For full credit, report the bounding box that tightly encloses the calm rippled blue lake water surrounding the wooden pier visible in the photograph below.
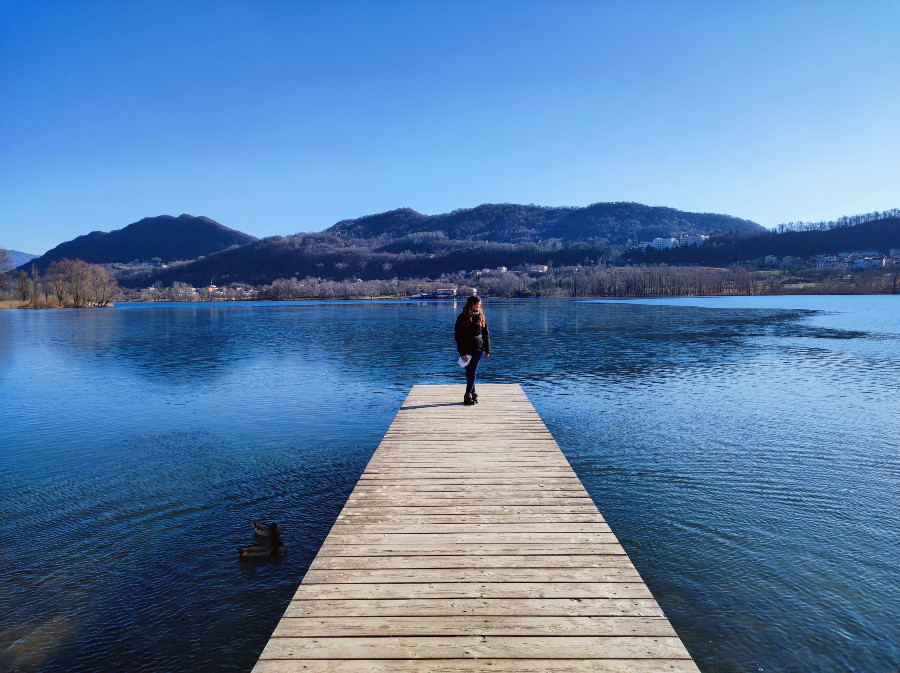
[0,296,900,673]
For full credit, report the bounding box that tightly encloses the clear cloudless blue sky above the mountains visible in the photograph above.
[0,0,900,253]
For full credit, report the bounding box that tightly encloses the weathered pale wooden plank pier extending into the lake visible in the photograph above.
[253,385,698,673]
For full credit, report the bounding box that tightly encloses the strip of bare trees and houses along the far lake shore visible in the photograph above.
[0,252,900,308]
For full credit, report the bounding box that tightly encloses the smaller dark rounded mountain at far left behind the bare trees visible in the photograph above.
[23,215,257,271]
